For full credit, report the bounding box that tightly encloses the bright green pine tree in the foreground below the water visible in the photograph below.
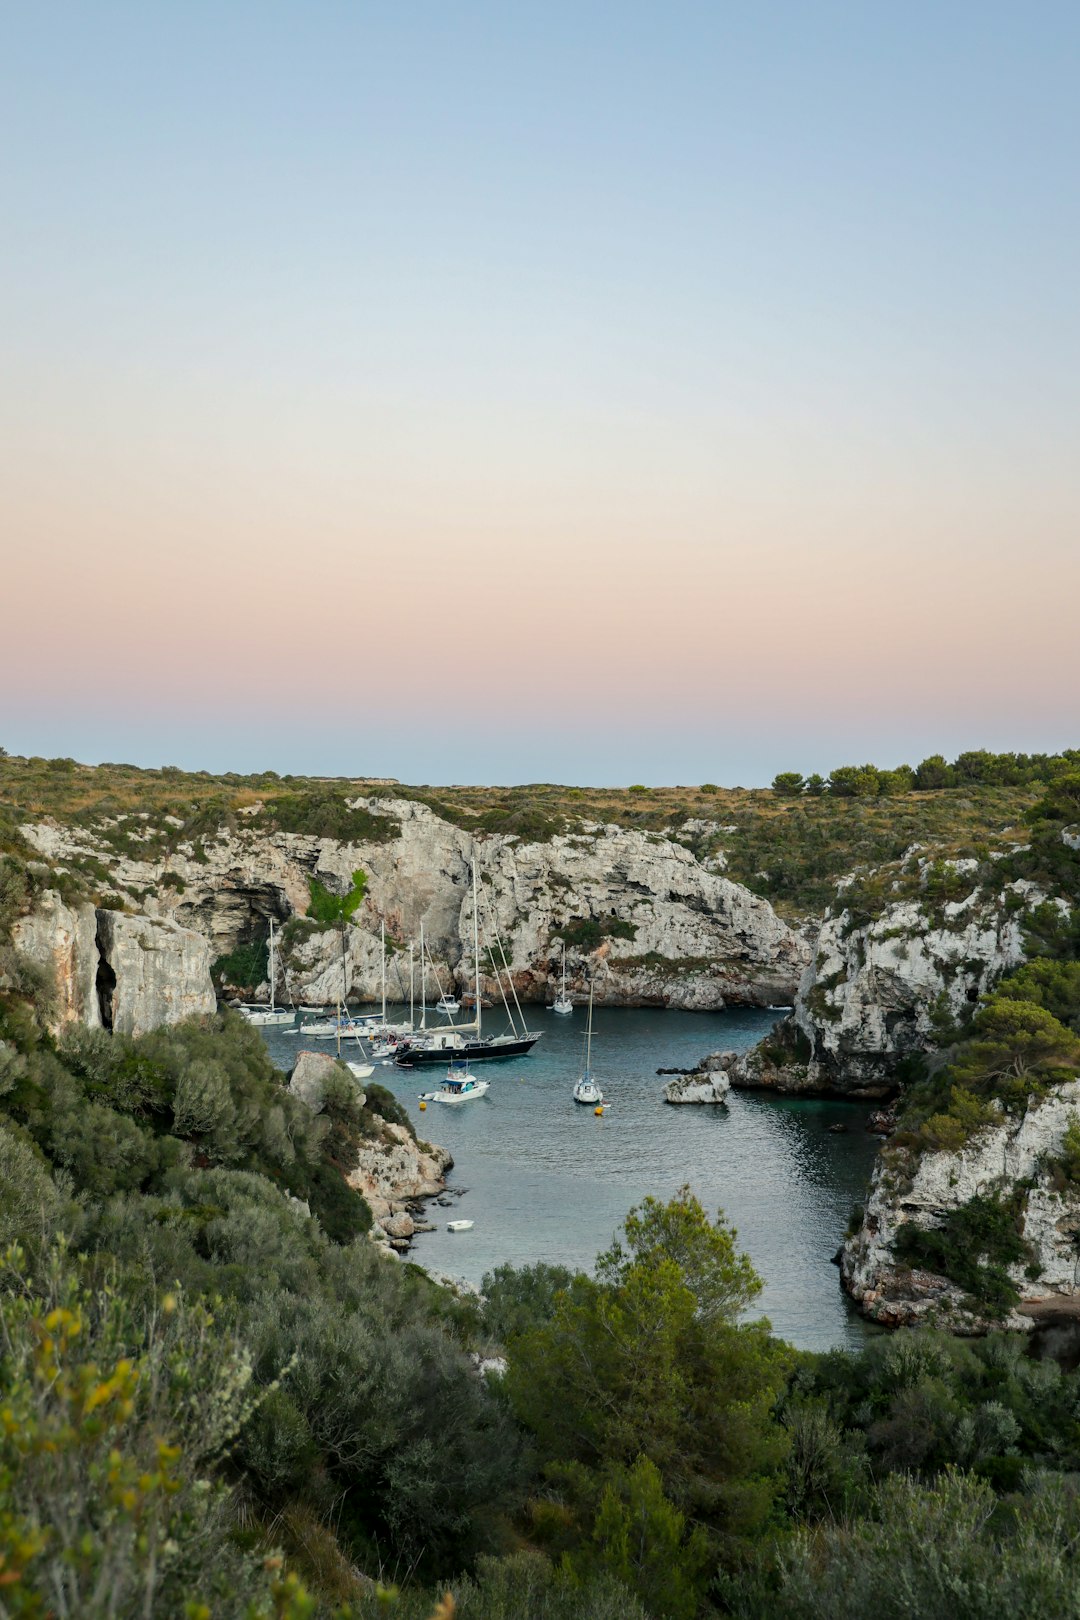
[507,1187,789,1555]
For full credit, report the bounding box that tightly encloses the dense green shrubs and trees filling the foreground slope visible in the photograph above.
[0,920,1080,1620]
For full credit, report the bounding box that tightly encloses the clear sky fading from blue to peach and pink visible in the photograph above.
[0,0,1080,786]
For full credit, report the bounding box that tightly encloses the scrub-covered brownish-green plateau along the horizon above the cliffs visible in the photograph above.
[0,753,1070,919]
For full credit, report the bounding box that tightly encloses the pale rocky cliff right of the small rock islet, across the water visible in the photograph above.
[730,862,1043,1097]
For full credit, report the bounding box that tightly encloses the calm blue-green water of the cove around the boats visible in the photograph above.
[264,1008,876,1349]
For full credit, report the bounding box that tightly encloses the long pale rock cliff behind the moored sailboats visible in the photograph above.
[24,800,808,1009]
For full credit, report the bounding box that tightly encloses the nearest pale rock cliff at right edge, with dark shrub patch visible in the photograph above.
[840,1079,1080,1332]
